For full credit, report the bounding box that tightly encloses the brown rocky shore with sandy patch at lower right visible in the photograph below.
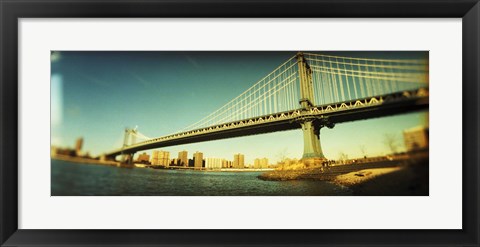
[258,158,428,196]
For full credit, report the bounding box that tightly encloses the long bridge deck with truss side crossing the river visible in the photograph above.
[104,88,429,157]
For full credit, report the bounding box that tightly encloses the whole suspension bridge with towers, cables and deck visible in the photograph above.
[103,52,429,162]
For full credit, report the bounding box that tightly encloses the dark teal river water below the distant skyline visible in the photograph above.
[51,160,350,196]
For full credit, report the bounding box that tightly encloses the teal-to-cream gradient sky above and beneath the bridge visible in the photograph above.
[51,51,428,164]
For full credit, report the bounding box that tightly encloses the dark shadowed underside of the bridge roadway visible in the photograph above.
[105,96,429,158]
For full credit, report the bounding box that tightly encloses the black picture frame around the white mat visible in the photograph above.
[0,0,480,246]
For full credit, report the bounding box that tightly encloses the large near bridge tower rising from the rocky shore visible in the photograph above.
[297,52,333,163]
